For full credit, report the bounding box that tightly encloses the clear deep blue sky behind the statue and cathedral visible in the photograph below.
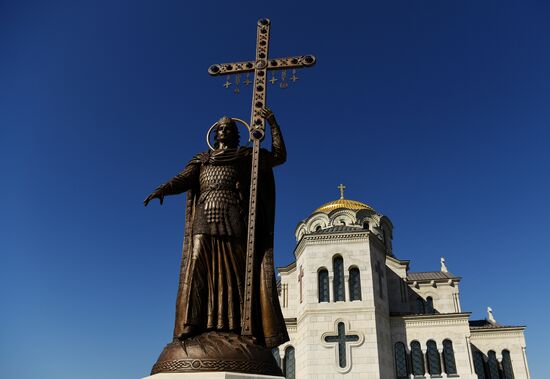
[0,0,550,379]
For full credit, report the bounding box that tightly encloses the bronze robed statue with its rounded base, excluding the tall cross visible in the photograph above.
[144,108,288,375]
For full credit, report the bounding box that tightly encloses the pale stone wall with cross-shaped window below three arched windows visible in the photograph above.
[291,235,391,379]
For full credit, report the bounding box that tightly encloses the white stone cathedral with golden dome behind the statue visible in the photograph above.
[273,189,530,379]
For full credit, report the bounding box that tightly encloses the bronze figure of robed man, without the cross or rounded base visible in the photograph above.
[144,108,288,348]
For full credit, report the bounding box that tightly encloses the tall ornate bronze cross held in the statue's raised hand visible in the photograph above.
[208,18,315,335]
